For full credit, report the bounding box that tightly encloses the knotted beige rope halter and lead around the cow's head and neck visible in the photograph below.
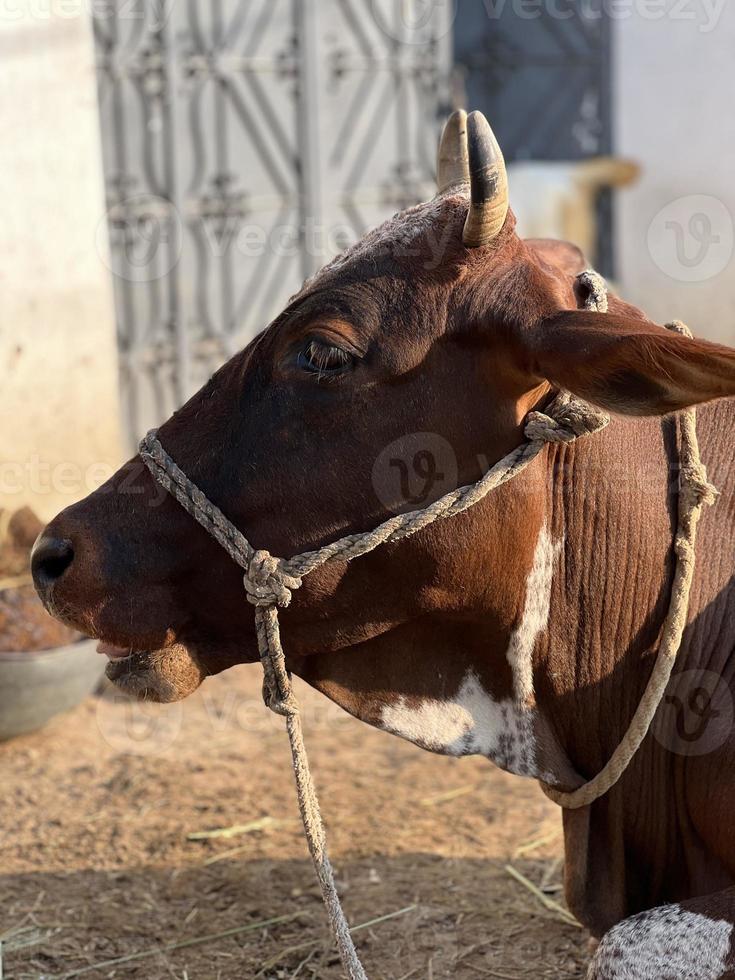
[140,270,714,980]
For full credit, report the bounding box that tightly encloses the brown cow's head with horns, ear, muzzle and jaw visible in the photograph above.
[33,112,735,756]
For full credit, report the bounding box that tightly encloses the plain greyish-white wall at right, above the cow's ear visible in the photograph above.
[614,0,735,344]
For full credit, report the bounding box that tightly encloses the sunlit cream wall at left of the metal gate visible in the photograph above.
[0,2,121,518]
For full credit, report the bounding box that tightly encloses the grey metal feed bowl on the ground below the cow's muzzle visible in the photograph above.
[0,640,106,740]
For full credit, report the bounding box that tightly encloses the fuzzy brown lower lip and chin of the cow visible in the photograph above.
[97,641,206,703]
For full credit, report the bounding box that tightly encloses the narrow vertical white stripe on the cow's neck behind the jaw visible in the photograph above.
[506,525,562,708]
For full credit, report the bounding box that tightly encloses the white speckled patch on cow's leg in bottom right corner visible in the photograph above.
[588,905,733,980]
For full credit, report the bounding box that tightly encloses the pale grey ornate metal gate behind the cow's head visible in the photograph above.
[93,0,453,442]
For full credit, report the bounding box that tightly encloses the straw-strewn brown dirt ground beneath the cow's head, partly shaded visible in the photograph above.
[0,667,586,980]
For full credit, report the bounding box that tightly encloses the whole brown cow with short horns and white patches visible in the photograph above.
[33,113,735,980]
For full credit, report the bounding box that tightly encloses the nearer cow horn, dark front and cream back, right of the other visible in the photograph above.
[462,112,508,248]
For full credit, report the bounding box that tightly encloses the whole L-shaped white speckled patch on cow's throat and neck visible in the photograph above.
[380,527,561,778]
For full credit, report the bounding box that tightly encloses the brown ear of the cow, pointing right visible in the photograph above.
[527,310,735,415]
